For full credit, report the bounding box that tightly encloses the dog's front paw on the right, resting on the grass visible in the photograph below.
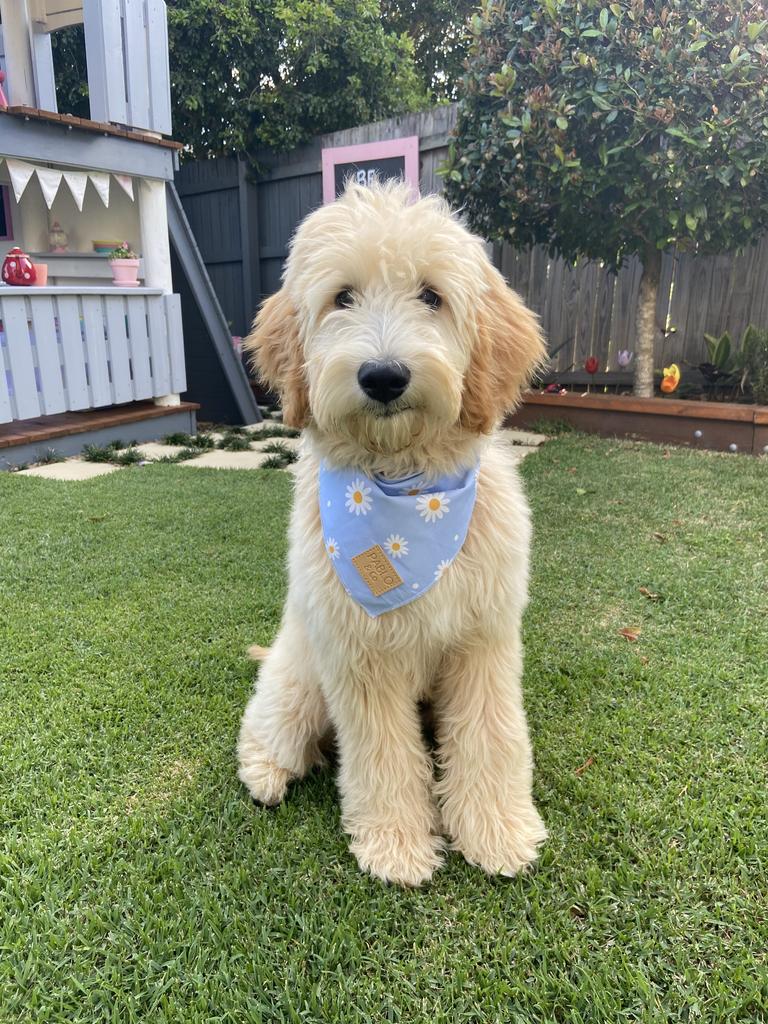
[447,805,547,876]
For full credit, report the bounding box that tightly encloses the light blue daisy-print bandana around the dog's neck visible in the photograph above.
[319,463,477,617]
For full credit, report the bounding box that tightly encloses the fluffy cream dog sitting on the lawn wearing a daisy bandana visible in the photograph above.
[238,182,547,886]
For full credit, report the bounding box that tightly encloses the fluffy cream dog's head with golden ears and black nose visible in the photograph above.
[247,183,545,464]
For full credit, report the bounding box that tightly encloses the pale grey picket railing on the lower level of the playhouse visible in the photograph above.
[0,287,186,423]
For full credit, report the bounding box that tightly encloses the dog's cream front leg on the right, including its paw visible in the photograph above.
[435,622,547,874]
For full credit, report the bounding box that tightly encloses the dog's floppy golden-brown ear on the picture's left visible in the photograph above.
[244,289,309,428]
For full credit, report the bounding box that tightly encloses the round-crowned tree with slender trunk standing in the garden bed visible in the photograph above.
[446,0,768,395]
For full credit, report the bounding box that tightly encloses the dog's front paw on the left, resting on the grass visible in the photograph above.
[349,828,443,886]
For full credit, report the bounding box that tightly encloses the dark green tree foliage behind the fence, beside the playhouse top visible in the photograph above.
[53,0,429,158]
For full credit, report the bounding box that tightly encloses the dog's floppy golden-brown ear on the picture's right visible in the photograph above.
[460,263,546,434]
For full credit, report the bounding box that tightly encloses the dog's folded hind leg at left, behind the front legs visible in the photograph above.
[238,615,329,805]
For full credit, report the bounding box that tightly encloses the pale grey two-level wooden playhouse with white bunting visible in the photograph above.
[0,0,197,468]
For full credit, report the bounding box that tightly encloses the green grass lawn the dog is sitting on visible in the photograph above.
[0,436,768,1024]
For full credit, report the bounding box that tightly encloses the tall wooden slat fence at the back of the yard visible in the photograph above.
[176,99,768,373]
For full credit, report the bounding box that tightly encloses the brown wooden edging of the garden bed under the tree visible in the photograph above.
[506,391,768,455]
